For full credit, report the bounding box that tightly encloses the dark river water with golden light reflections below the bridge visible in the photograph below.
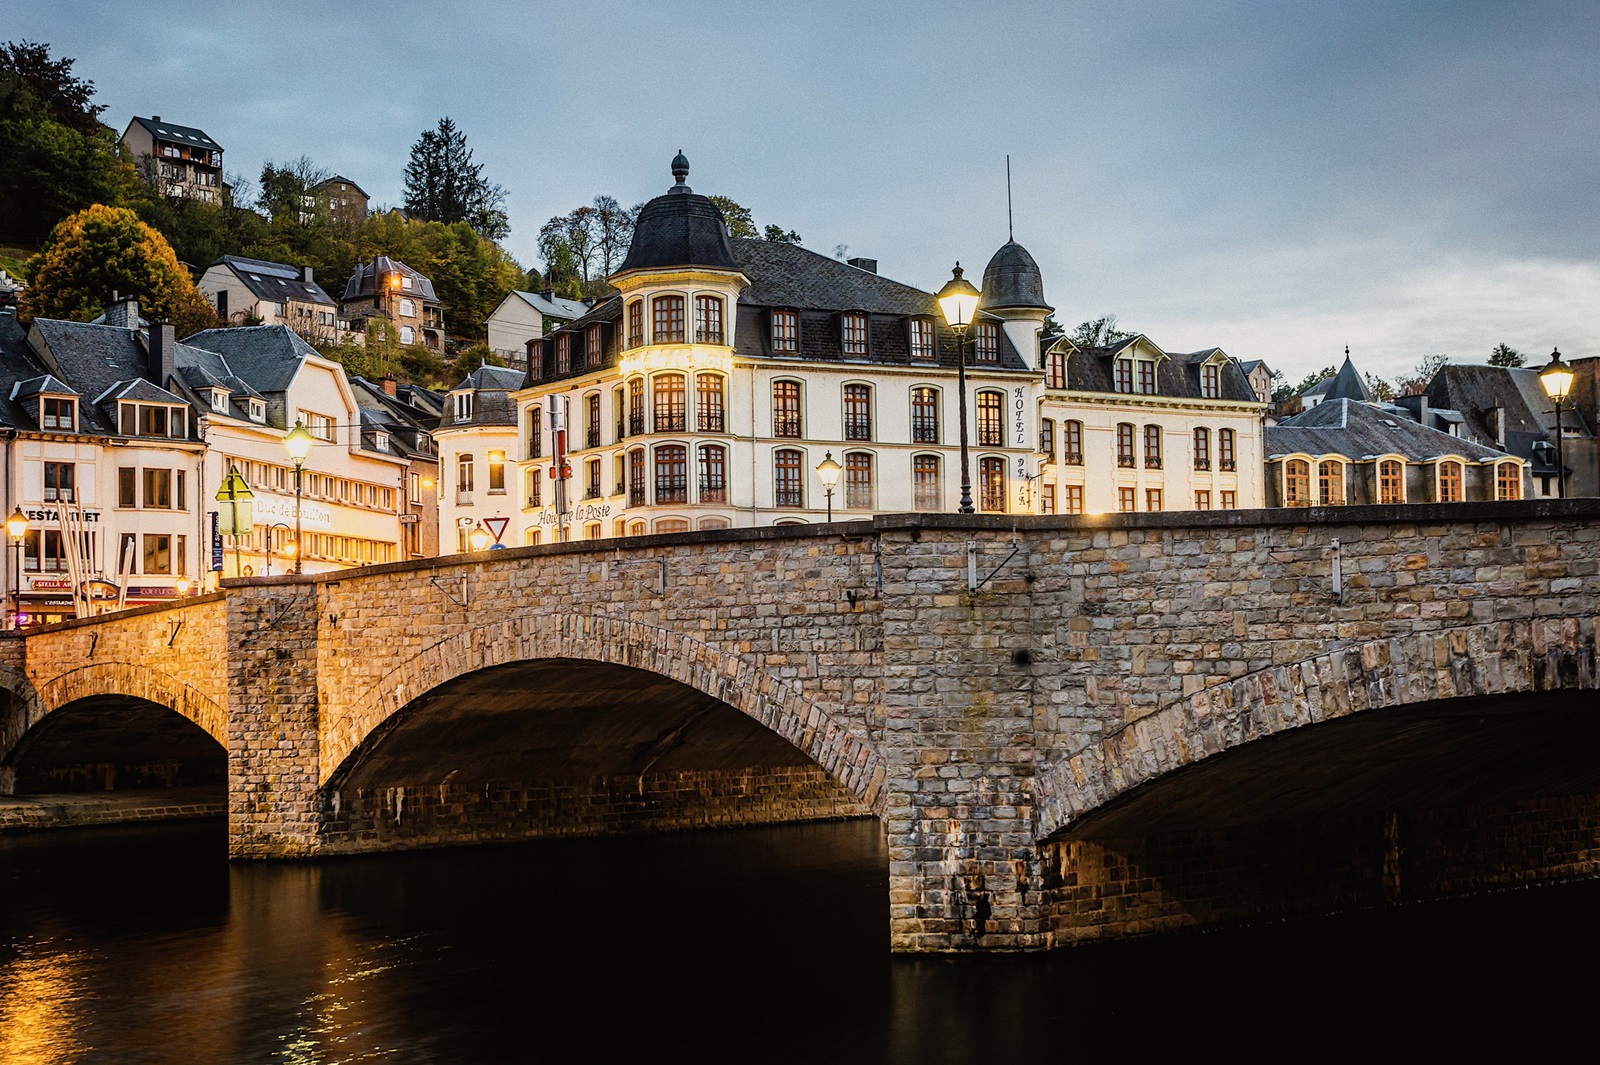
[0,822,1600,1065]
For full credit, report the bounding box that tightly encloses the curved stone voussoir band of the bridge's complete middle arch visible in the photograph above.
[318,612,886,817]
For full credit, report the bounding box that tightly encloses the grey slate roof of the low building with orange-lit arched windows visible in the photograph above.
[1264,400,1510,462]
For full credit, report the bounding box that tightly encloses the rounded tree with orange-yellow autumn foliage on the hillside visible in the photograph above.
[19,205,216,336]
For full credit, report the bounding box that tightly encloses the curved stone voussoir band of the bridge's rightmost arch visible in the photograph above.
[1037,617,1600,843]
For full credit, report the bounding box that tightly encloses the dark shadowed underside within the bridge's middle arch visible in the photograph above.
[322,657,872,852]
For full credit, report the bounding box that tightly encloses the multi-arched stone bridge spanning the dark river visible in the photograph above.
[0,501,1600,950]
